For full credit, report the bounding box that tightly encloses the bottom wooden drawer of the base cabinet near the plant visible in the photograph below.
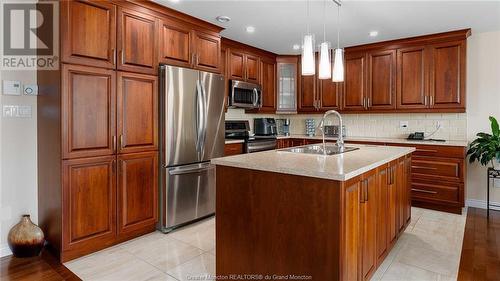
[411,181,460,203]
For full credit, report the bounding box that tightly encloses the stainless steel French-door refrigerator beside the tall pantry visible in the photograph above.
[159,65,224,232]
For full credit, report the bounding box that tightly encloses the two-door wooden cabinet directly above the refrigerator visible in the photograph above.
[160,18,221,73]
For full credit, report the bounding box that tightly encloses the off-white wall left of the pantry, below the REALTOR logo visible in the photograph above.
[0,71,38,256]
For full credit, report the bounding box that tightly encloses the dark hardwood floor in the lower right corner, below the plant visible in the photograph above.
[458,208,500,281]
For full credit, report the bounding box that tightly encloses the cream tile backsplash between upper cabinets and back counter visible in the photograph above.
[226,109,467,140]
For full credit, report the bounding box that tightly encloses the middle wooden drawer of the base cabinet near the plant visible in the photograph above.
[411,157,464,182]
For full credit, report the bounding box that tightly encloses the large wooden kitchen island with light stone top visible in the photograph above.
[212,145,415,281]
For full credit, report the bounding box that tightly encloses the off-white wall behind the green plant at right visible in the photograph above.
[467,31,500,207]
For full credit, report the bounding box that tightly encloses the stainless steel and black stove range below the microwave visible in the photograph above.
[226,120,277,153]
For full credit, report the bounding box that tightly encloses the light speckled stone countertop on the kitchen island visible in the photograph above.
[212,144,415,181]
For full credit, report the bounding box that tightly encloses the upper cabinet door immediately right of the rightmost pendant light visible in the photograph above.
[342,53,366,111]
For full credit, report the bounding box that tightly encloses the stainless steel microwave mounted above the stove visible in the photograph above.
[229,80,262,108]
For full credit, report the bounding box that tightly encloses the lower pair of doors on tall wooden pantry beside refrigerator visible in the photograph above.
[61,151,158,261]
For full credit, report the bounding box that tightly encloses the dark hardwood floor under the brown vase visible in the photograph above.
[0,250,81,281]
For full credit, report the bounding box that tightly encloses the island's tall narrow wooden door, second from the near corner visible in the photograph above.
[361,170,378,280]
